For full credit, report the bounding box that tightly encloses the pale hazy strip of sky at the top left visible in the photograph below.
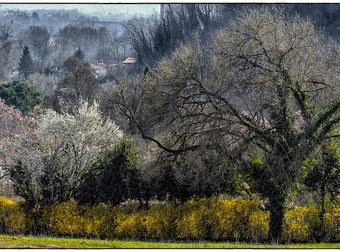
[0,3,160,15]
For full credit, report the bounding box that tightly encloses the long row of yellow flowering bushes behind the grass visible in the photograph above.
[0,198,340,242]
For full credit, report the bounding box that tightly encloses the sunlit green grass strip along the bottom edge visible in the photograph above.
[0,235,340,249]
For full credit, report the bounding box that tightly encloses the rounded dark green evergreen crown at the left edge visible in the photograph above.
[0,81,43,114]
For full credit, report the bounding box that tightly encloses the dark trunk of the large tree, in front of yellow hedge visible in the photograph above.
[269,196,286,243]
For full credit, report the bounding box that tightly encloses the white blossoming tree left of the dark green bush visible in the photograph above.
[9,99,123,204]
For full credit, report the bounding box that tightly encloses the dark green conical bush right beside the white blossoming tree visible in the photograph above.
[75,137,142,205]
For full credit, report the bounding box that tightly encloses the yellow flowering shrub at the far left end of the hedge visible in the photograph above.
[0,197,25,233]
